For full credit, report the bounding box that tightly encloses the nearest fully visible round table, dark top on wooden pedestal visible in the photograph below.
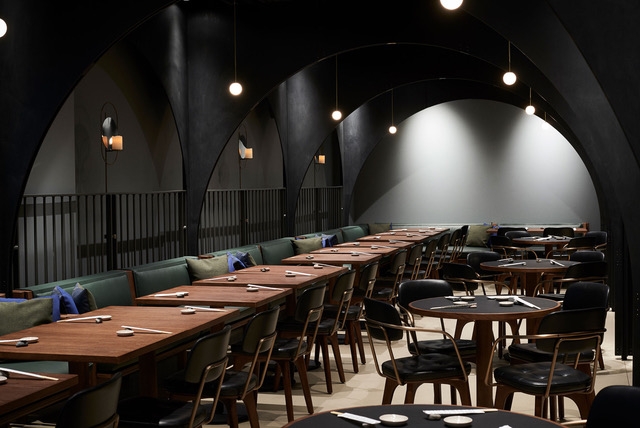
[409,296,560,407]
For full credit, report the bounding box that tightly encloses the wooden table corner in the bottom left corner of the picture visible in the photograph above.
[0,372,78,427]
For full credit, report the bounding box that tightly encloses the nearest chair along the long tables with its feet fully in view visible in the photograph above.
[271,284,327,421]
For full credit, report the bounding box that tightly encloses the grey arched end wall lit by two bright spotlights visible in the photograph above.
[352,100,600,230]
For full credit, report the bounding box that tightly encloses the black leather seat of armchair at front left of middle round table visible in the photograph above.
[382,354,471,382]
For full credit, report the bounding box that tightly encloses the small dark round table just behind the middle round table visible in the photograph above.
[480,259,580,296]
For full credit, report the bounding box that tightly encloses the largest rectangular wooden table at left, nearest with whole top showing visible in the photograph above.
[0,306,238,396]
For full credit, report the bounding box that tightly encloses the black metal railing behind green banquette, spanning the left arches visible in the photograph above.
[13,187,342,287]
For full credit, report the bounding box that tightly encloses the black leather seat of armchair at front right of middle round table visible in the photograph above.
[493,362,591,395]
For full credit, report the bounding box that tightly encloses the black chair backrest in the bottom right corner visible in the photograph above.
[585,385,640,428]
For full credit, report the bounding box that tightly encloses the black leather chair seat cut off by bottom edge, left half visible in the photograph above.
[118,397,211,428]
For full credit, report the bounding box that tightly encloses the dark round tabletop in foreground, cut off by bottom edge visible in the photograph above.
[284,404,562,428]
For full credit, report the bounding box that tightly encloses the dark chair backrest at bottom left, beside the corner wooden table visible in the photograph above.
[56,372,122,428]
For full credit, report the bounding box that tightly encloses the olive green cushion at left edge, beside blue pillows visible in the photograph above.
[0,299,53,335]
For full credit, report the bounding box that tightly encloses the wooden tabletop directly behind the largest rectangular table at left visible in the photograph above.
[136,285,292,309]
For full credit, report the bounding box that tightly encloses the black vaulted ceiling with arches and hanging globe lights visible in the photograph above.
[0,0,640,383]
